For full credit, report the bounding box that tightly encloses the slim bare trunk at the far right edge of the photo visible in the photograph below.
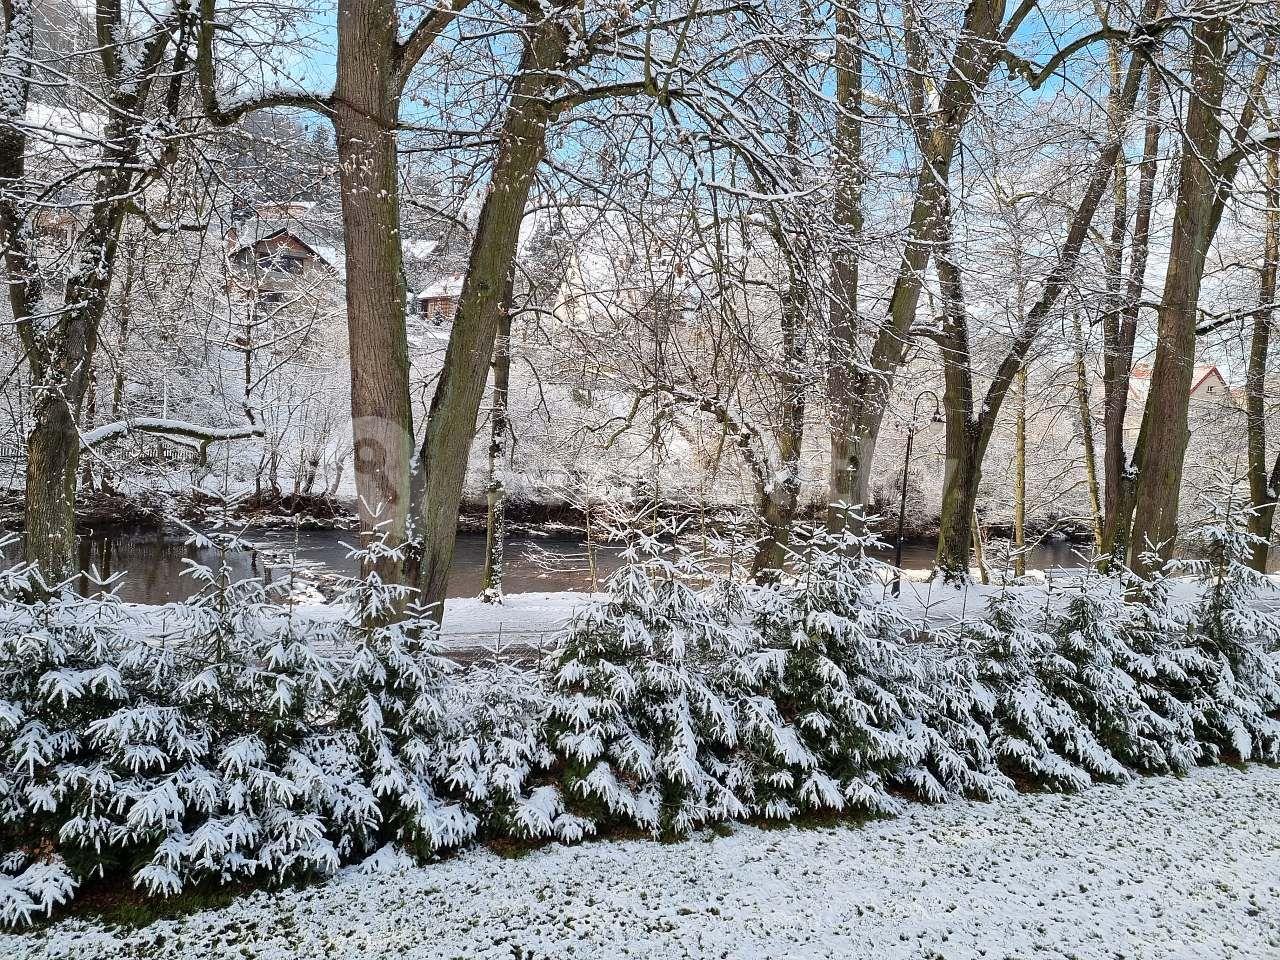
[1244,140,1280,573]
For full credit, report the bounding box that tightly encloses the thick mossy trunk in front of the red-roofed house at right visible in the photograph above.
[1129,18,1229,568]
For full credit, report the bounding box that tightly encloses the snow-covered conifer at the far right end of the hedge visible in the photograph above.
[1178,497,1280,762]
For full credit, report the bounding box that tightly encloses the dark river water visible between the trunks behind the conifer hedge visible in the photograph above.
[0,530,1100,603]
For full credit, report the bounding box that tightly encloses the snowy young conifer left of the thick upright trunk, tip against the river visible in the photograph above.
[128,534,351,895]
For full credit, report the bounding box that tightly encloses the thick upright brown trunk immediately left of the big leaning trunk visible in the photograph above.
[333,0,413,581]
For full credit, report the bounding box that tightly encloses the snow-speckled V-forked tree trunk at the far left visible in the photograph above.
[0,0,195,585]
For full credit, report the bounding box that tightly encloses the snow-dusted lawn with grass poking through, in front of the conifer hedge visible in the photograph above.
[10,767,1280,960]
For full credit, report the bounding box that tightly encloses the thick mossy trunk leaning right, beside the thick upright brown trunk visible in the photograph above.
[412,18,570,617]
